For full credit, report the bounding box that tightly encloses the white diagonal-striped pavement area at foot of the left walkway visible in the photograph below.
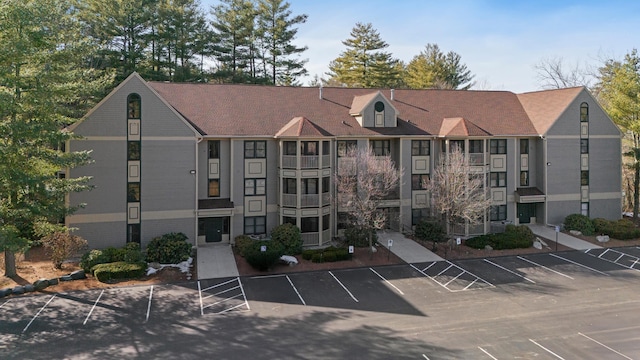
[197,277,249,315]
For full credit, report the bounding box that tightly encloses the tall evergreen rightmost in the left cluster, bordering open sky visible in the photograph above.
[258,0,308,85]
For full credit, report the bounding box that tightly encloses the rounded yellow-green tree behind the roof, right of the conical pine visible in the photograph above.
[404,44,474,90]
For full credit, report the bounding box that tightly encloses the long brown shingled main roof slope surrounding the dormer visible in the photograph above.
[149,82,568,137]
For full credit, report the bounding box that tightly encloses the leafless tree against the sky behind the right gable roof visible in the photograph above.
[533,57,593,89]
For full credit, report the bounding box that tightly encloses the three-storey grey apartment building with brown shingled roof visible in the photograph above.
[66,74,621,248]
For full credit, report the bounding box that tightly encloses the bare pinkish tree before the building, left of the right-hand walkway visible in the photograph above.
[335,147,402,248]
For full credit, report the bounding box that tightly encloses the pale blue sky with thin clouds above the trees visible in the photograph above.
[201,0,640,93]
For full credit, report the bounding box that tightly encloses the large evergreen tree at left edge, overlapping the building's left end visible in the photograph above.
[0,0,111,276]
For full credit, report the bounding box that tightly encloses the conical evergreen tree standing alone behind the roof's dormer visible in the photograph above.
[327,23,400,88]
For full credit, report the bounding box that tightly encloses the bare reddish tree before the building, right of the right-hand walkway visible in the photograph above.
[427,148,491,234]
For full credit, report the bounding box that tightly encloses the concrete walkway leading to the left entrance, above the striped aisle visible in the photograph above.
[197,244,239,280]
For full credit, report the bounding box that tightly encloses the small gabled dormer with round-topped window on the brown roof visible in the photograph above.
[349,90,398,128]
